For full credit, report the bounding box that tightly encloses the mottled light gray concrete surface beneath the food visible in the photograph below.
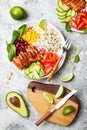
[0,0,87,130]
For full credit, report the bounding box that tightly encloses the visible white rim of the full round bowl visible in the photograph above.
[12,21,66,78]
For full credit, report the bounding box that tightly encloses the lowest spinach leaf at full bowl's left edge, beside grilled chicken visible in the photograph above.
[7,43,16,61]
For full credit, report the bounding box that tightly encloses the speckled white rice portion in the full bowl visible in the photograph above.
[33,26,61,53]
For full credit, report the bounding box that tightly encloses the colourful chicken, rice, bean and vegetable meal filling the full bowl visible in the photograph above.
[7,19,63,79]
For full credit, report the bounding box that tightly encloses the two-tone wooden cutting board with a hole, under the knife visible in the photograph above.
[27,81,79,126]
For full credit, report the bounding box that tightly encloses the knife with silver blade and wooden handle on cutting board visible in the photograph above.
[35,90,77,126]
